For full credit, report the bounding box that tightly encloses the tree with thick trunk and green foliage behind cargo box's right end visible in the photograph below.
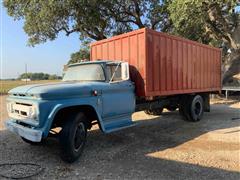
[168,0,240,83]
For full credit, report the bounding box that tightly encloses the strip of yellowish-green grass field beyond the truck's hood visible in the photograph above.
[0,80,59,94]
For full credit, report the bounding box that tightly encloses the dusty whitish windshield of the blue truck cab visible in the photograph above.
[63,64,105,81]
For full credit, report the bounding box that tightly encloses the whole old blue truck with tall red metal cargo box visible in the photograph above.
[6,28,221,162]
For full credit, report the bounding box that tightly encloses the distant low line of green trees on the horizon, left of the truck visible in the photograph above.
[18,73,61,80]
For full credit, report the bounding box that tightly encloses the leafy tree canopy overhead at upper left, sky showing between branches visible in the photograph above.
[4,0,171,46]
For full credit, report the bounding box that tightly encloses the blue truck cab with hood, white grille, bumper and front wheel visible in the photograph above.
[6,61,136,162]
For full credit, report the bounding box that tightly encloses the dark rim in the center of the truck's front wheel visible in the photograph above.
[74,122,86,151]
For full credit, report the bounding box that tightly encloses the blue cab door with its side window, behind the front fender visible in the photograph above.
[102,64,135,132]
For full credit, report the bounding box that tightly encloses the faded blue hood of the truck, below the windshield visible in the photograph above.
[9,82,106,99]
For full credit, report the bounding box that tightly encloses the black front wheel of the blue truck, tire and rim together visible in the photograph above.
[60,112,87,163]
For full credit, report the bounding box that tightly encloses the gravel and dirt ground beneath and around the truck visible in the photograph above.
[0,96,240,180]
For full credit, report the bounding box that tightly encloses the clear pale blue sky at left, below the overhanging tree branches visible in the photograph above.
[0,3,80,79]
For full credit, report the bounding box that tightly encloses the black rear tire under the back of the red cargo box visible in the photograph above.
[179,95,204,122]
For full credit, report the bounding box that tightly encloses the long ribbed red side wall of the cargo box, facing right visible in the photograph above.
[145,29,221,96]
